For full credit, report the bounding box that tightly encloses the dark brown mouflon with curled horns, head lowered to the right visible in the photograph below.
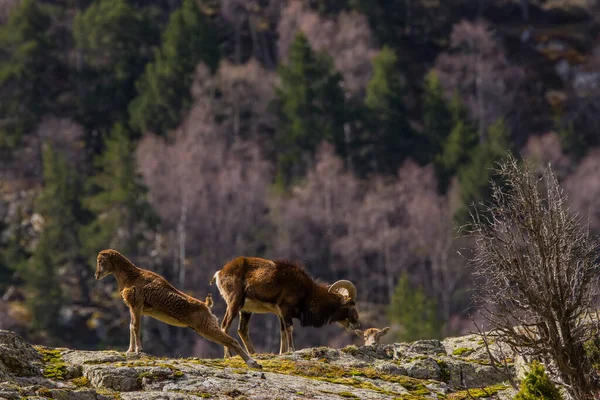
[210,257,360,356]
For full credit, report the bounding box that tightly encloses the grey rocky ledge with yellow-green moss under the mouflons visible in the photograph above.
[0,330,514,400]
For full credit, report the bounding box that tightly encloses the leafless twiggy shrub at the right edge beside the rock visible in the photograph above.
[470,156,600,399]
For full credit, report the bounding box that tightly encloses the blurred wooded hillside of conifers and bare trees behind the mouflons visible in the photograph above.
[0,0,600,356]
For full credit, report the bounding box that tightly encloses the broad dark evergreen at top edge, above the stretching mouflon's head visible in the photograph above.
[73,0,160,134]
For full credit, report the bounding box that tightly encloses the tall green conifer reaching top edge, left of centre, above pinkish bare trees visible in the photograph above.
[129,0,220,134]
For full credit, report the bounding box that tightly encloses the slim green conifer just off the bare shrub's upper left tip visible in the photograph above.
[456,118,512,221]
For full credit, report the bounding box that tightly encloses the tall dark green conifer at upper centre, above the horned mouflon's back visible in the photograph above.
[275,33,345,186]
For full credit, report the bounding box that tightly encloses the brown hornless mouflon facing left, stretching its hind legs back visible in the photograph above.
[96,250,261,368]
